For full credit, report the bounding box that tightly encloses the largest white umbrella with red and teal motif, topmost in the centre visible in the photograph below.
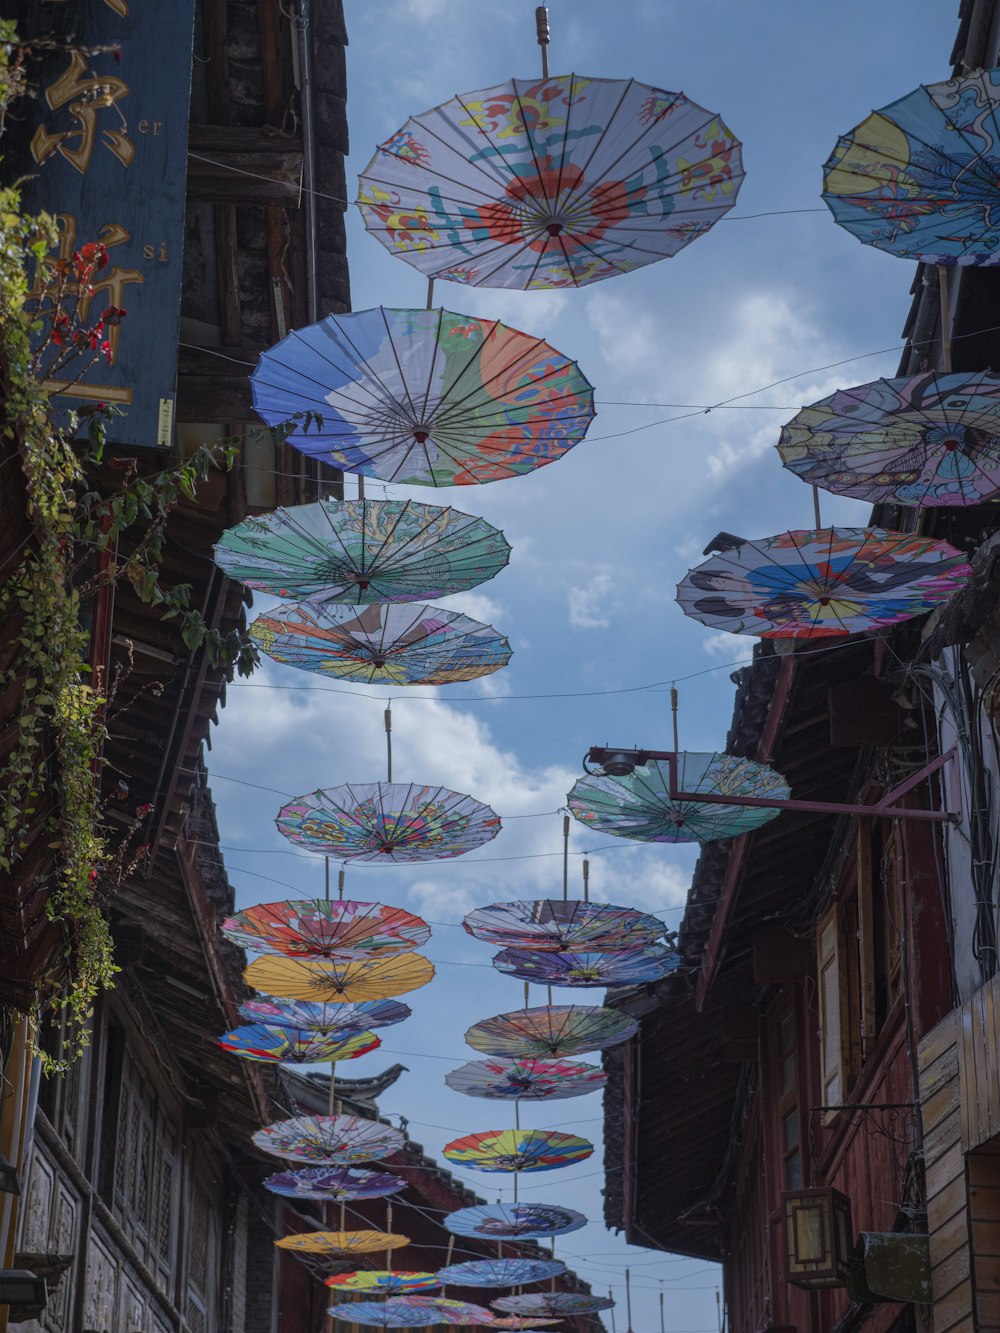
[357,75,743,288]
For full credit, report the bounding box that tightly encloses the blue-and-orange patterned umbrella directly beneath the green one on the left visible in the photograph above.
[249,603,511,685]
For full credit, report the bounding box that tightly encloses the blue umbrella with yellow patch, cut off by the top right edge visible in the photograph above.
[823,69,1000,264]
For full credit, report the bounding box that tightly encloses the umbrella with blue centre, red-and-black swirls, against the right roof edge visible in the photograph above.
[677,528,972,639]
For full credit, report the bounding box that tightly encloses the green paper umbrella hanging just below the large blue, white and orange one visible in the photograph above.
[215,500,511,605]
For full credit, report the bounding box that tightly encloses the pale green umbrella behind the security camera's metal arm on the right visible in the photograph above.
[567,750,789,842]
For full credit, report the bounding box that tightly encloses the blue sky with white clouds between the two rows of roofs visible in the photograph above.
[211,0,957,1333]
